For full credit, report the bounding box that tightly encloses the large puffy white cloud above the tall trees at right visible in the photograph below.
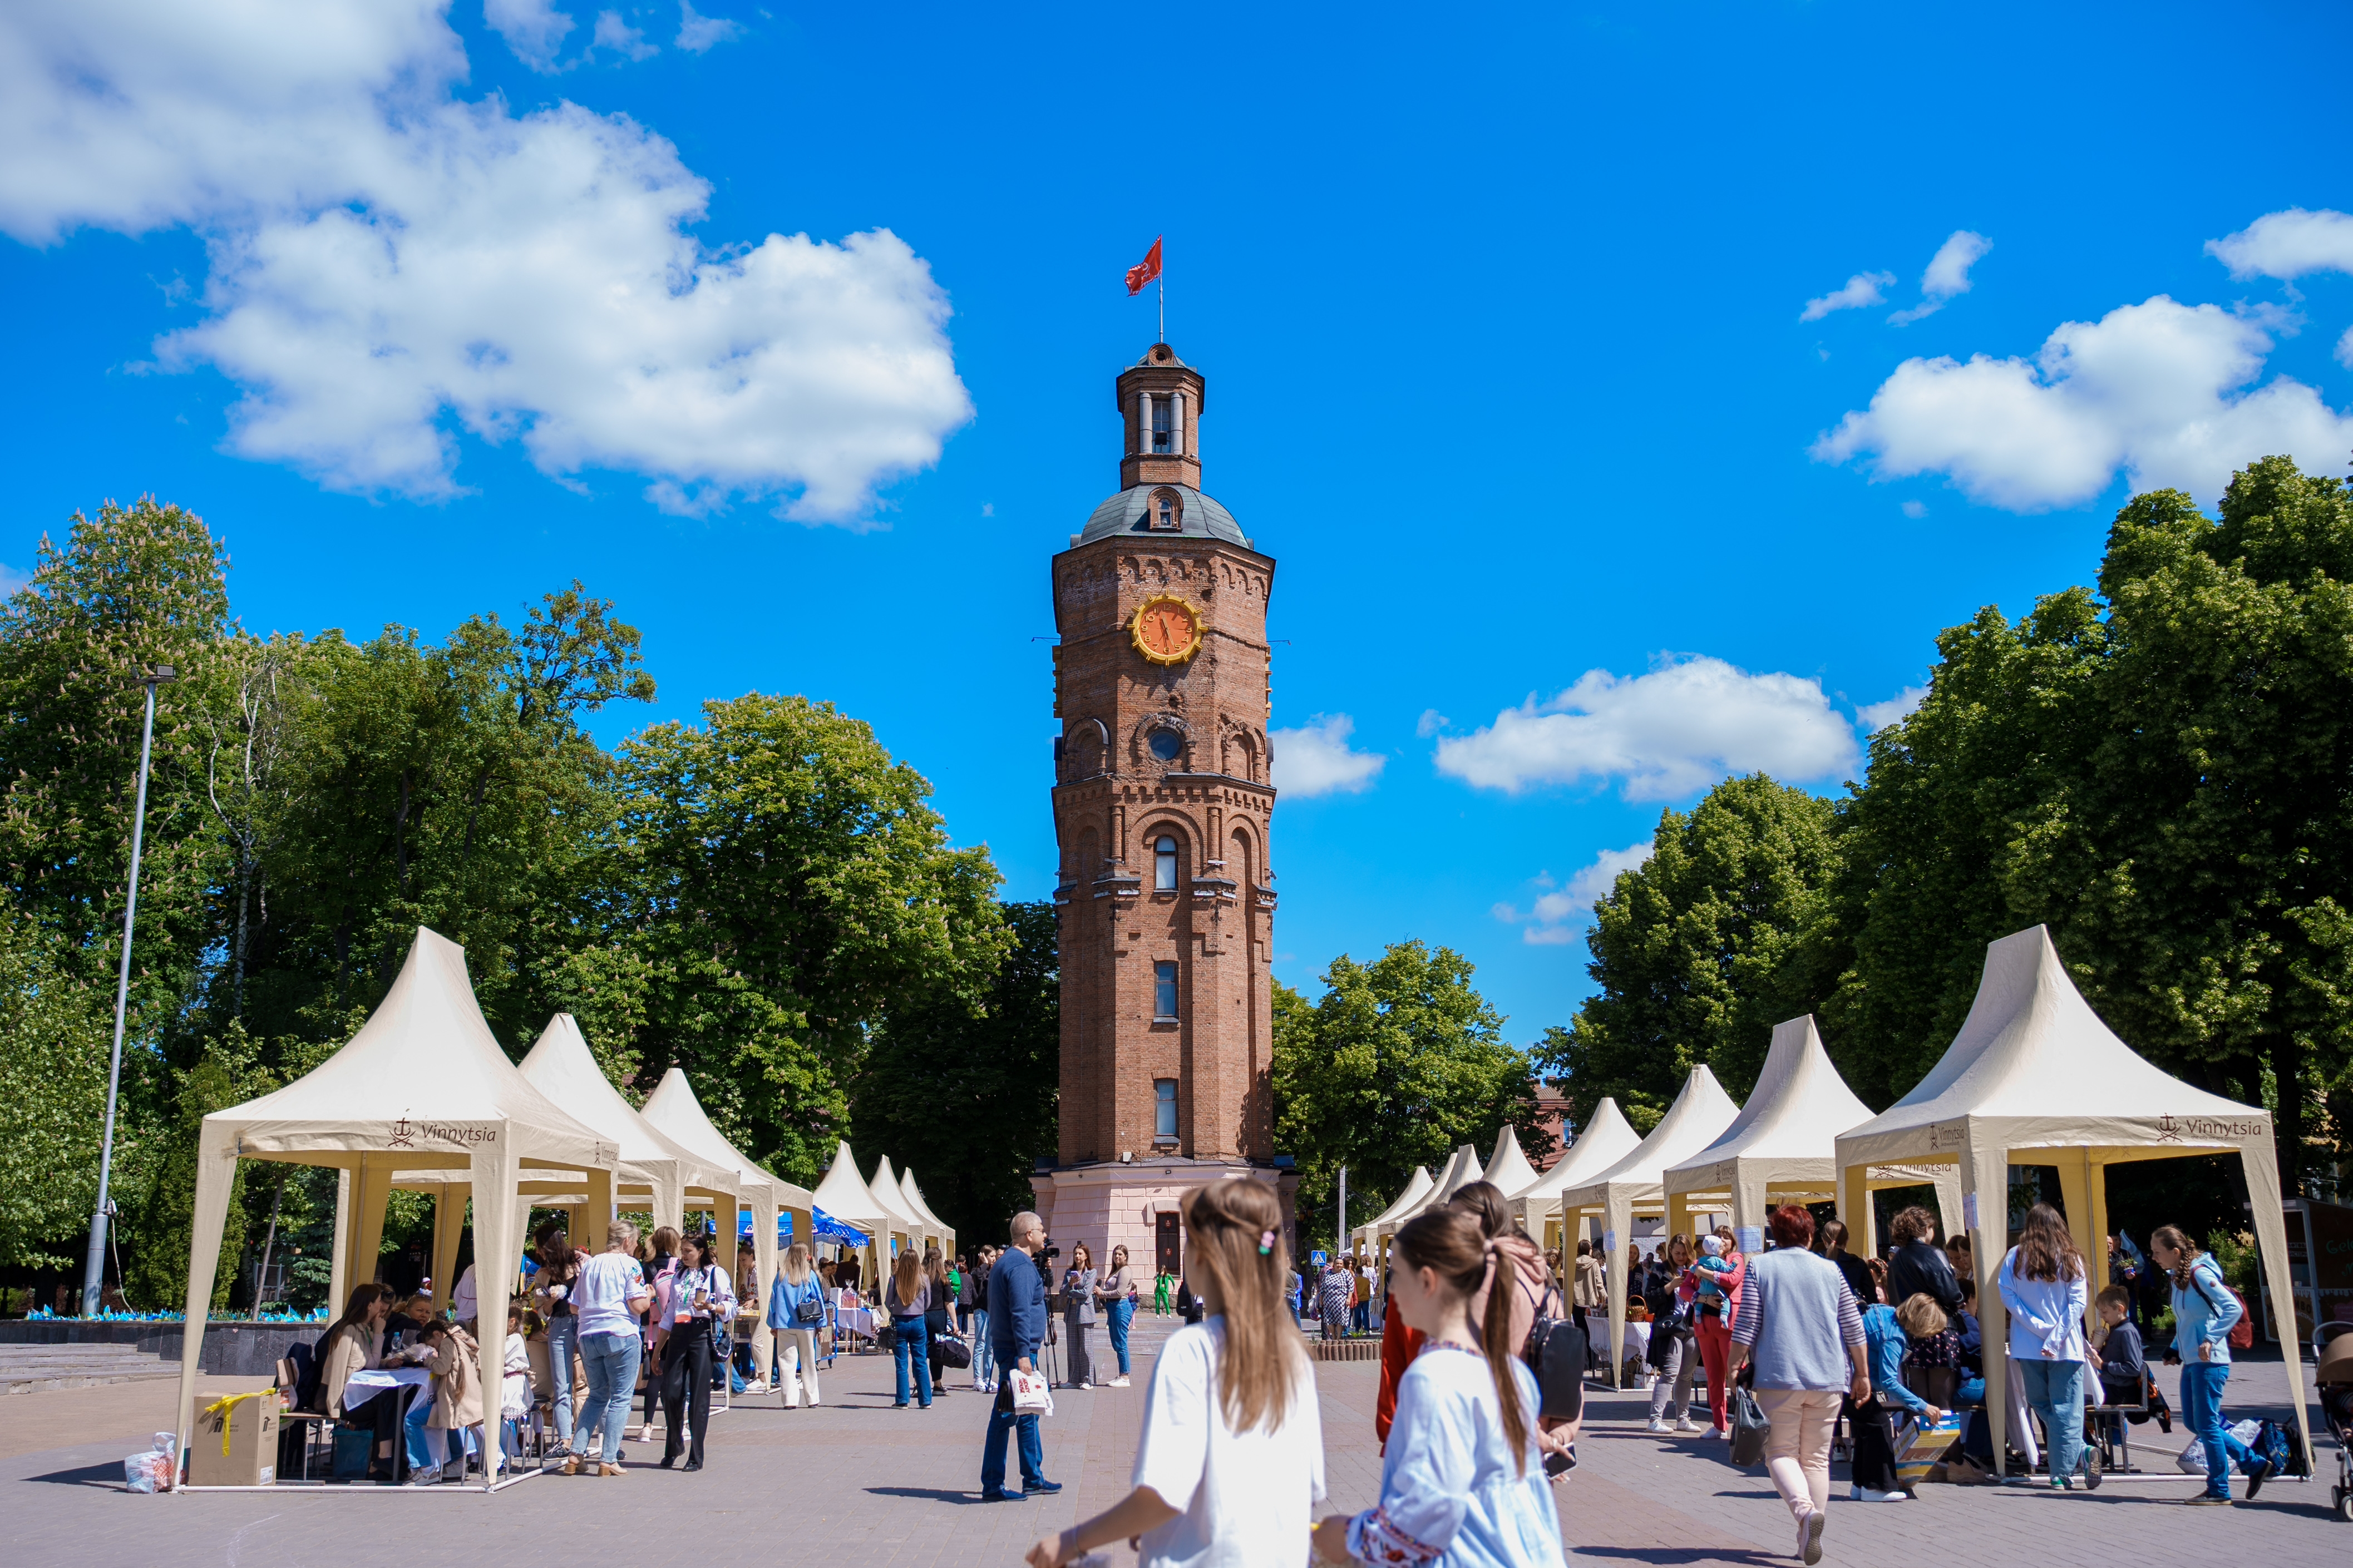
[1812,294,2353,512]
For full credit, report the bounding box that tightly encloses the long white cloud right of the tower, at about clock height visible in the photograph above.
[1438,658,1857,799]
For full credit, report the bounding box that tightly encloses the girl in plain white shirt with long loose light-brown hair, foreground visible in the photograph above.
[1028,1178,1325,1568]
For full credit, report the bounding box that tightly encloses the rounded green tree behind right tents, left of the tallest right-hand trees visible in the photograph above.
[1539,773,1838,1114]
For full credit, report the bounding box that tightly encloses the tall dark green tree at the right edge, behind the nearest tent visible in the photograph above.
[2010,456,2353,1192]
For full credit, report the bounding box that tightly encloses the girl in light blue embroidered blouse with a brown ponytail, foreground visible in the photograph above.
[1315,1208,1562,1568]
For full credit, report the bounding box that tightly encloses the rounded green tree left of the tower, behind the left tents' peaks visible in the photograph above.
[605,694,1012,1183]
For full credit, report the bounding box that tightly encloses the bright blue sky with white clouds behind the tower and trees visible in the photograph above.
[0,0,2353,1041]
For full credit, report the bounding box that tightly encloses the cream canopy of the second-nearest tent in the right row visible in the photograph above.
[1659,1013,1960,1255]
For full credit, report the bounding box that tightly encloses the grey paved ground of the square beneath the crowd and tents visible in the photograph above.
[0,1319,2353,1568]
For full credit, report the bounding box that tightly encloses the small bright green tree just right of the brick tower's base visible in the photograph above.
[1273,941,1553,1236]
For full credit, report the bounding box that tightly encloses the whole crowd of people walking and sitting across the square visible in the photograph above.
[289,1180,2278,1568]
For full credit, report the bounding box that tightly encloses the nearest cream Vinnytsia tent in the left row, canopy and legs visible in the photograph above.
[179,926,619,1483]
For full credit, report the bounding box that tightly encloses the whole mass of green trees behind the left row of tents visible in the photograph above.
[0,501,1016,1305]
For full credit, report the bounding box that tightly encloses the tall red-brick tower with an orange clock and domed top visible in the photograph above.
[1033,343,1299,1272]
